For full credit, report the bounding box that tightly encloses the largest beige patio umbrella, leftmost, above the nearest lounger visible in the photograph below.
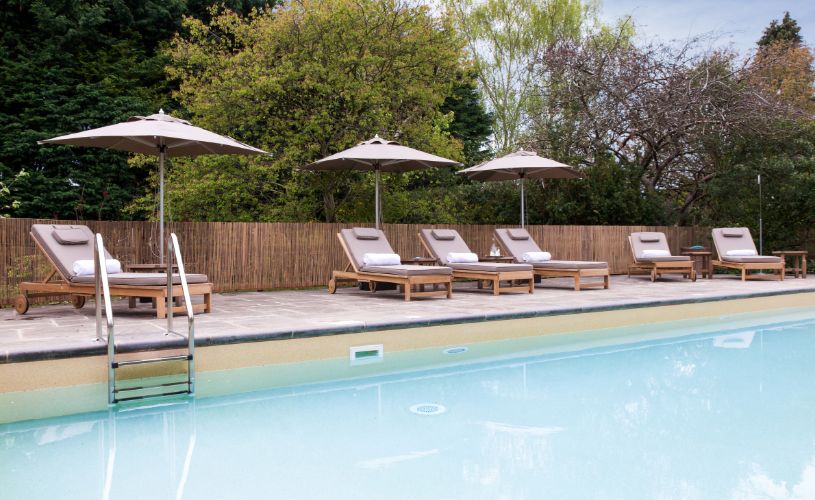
[38,110,267,264]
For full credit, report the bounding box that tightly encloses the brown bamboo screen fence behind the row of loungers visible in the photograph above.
[0,218,710,305]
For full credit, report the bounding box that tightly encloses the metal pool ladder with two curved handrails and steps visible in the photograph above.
[93,233,195,405]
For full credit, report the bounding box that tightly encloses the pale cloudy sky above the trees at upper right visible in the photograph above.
[600,0,815,54]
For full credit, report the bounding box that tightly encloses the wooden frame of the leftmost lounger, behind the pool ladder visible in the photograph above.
[14,233,212,318]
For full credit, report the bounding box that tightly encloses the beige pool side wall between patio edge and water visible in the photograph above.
[0,293,815,423]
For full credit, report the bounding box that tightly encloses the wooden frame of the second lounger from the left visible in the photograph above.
[328,233,453,302]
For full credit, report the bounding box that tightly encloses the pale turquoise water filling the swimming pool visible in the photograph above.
[0,310,815,500]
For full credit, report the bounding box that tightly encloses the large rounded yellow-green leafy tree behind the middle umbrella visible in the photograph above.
[167,0,464,221]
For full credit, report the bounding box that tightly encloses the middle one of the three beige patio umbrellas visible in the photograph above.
[300,135,459,229]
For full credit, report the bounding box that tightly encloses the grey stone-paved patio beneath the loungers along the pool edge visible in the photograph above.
[0,275,815,363]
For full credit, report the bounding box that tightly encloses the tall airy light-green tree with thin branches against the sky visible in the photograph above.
[445,0,596,152]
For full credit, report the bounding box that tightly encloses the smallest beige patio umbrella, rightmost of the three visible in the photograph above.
[458,149,583,227]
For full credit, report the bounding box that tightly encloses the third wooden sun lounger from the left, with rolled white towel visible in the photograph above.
[417,229,535,295]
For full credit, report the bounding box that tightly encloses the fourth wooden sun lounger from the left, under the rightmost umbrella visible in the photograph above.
[495,228,609,291]
